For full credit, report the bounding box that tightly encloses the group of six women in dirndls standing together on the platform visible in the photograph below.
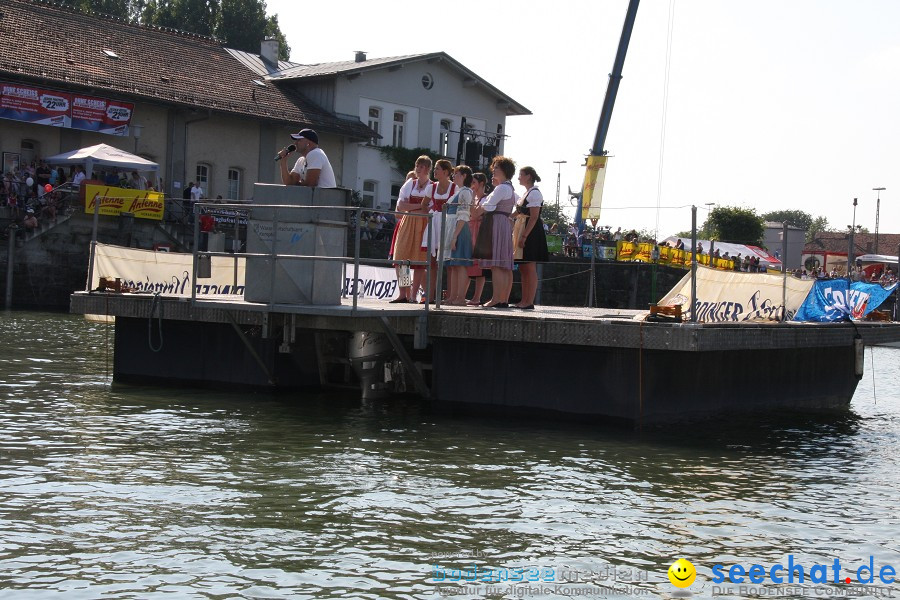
[391,156,548,310]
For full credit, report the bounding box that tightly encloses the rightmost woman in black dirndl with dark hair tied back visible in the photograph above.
[513,167,549,310]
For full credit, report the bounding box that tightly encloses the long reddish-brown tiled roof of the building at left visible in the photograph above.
[0,0,374,139]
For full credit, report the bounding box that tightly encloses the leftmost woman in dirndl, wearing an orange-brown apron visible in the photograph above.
[390,155,434,303]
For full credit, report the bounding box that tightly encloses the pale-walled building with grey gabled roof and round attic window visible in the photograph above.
[267,52,531,208]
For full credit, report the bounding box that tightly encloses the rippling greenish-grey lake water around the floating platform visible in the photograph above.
[0,312,900,598]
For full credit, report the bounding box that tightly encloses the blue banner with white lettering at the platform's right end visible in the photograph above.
[794,279,897,322]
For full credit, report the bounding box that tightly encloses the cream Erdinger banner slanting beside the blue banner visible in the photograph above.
[659,267,813,323]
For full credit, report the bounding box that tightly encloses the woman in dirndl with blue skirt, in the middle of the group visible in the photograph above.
[446,165,475,306]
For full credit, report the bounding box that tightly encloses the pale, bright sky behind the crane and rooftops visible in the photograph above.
[267,0,900,237]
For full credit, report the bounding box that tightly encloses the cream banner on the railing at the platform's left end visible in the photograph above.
[90,244,246,297]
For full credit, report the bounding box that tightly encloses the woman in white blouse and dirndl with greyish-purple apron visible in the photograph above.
[475,156,516,308]
